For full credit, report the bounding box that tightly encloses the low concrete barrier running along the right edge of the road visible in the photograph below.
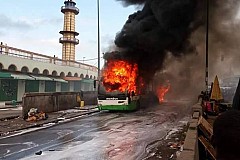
[177,103,202,160]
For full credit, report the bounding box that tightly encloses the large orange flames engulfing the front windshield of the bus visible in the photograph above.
[103,60,138,92]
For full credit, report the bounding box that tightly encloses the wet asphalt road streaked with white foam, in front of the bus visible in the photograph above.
[0,101,191,160]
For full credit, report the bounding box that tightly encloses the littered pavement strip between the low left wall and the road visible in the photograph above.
[0,106,98,137]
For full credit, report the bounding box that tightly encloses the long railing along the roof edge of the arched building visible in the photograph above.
[0,44,97,72]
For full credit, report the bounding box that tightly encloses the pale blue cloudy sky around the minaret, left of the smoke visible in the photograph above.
[0,0,136,66]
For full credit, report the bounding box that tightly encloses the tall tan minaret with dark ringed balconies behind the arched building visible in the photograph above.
[59,0,79,61]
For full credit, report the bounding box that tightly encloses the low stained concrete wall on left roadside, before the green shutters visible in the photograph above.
[22,91,97,118]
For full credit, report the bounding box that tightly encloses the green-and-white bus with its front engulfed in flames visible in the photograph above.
[98,60,140,111]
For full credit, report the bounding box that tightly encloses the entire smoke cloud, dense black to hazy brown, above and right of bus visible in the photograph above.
[105,0,240,100]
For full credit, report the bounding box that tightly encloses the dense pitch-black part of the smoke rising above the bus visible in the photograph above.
[104,0,201,83]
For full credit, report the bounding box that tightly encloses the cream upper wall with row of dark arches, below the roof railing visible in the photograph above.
[0,49,97,78]
